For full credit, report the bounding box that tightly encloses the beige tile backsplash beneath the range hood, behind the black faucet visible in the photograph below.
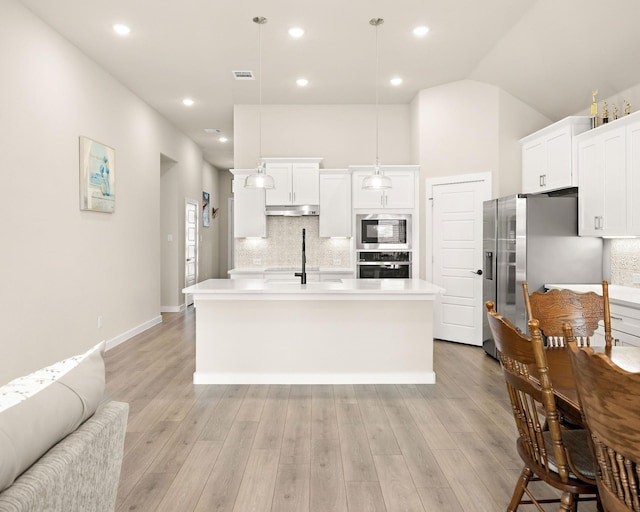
[234,216,352,268]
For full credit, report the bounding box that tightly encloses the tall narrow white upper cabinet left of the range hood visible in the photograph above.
[231,169,267,238]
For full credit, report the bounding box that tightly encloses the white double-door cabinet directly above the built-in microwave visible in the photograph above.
[351,165,419,210]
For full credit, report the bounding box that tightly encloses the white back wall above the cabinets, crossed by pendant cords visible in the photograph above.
[233,105,415,169]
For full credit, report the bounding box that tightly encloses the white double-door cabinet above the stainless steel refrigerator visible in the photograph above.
[520,116,591,194]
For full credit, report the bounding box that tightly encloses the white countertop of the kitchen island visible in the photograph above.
[182,279,444,300]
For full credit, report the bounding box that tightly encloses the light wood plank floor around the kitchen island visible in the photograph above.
[106,308,595,512]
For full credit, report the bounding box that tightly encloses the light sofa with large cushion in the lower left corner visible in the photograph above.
[0,343,129,512]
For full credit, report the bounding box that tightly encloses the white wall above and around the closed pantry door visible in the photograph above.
[411,80,551,277]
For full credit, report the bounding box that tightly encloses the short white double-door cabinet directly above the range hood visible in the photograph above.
[263,158,322,206]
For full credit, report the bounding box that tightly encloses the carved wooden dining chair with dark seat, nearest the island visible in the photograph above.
[486,302,597,512]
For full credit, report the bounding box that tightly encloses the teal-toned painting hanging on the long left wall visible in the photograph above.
[80,136,116,213]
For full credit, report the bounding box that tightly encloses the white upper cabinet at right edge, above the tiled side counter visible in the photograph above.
[576,112,640,237]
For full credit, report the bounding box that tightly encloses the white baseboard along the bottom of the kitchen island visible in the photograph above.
[193,372,436,384]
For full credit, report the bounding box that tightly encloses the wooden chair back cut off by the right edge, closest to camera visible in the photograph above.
[566,327,640,512]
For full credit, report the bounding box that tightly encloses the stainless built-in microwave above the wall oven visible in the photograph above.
[356,213,411,250]
